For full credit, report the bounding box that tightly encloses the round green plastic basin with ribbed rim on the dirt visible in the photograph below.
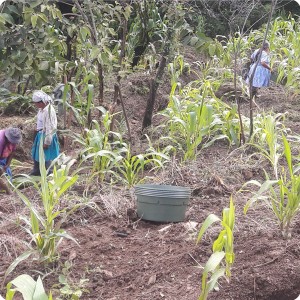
[134,184,191,222]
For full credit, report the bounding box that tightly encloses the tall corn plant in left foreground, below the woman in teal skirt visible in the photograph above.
[4,143,81,278]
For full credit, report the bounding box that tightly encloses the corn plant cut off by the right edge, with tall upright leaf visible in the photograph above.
[244,136,300,238]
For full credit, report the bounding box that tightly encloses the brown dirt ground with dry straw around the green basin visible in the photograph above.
[0,52,300,300]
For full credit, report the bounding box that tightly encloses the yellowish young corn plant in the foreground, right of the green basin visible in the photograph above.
[197,197,235,300]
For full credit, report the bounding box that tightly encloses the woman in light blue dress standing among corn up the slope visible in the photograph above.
[246,42,272,103]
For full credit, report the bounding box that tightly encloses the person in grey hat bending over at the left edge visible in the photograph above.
[0,128,22,194]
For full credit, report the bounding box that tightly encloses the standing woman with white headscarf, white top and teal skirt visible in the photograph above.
[30,91,59,176]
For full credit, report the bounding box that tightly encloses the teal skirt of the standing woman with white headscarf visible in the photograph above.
[31,131,59,161]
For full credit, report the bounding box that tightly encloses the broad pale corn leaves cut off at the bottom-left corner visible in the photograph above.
[4,274,53,300]
